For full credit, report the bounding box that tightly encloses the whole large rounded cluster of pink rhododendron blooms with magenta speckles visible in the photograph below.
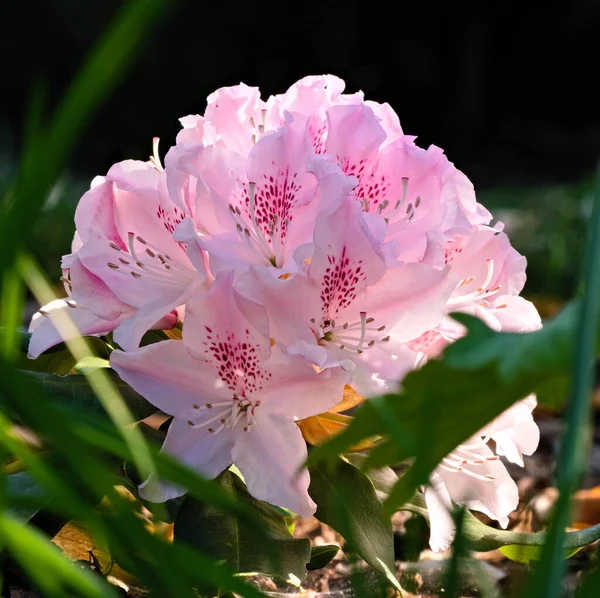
[30,76,540,550]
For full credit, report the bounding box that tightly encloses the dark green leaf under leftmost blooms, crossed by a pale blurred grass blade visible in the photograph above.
[12,371,156,419]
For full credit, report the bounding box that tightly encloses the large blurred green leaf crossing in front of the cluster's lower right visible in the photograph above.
[309,303,578,512]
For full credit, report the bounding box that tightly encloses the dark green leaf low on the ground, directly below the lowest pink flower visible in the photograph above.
[175,471,310,580]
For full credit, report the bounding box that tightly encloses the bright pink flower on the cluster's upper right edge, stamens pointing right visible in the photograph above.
[318,104,491,261]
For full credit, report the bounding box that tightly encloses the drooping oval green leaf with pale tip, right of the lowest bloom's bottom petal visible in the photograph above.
[308,459,394,575]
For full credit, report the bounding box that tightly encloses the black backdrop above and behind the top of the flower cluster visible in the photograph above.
[0,0,600,300]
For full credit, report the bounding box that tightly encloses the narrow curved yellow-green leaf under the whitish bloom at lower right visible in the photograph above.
[463,511,600,564]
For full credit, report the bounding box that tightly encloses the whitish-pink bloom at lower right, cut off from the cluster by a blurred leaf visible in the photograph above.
[425,396,540,552]
